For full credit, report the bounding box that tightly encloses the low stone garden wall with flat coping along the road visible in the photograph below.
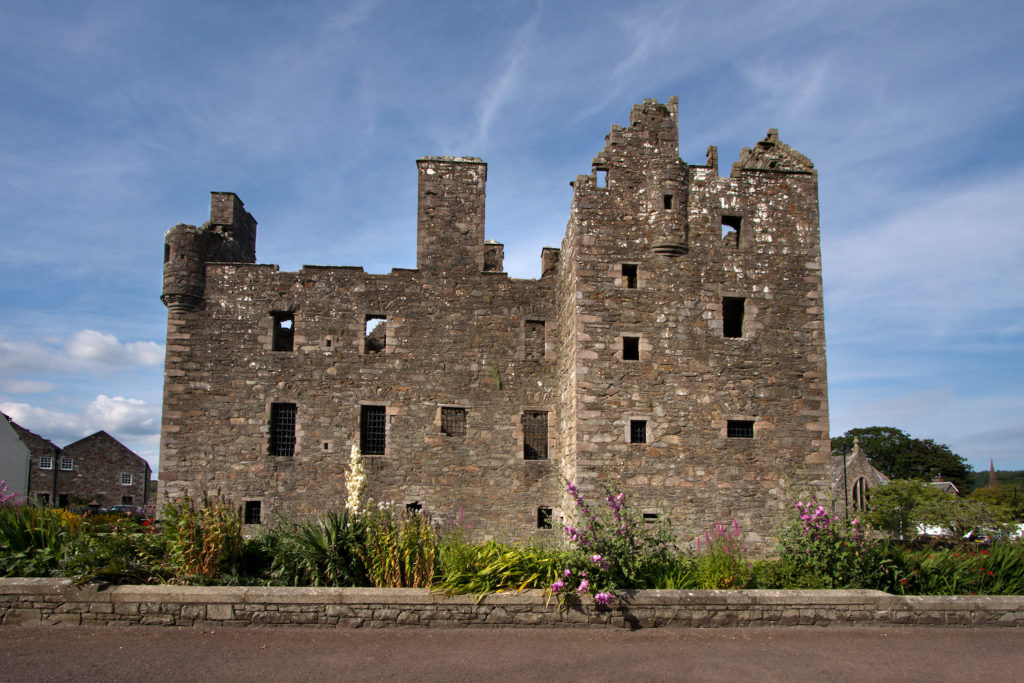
[0,579,1024,629]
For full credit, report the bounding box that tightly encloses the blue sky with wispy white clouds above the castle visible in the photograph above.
[0,0,1024,479]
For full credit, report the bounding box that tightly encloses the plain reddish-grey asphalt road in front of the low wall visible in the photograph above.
[0,627,1024,683]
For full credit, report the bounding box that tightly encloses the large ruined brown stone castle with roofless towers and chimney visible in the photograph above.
[160,97,829,547]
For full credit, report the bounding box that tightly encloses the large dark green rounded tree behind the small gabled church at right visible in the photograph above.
[831,427,974,495]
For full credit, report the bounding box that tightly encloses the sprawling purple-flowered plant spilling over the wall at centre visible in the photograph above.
[549,481,673,605]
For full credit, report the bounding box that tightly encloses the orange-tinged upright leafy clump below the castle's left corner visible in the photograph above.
[163,496,242,582]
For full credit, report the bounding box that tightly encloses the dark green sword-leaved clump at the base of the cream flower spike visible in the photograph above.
[262,511,369,586]
